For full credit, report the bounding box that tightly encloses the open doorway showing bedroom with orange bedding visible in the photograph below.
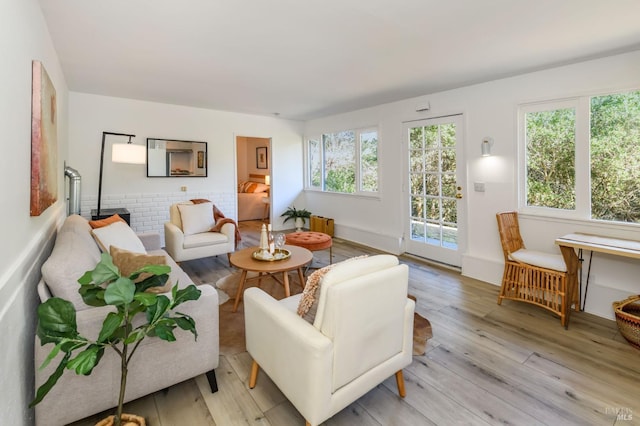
[236,136,272,223]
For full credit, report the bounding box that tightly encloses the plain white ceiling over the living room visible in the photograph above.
[39,0,640,120]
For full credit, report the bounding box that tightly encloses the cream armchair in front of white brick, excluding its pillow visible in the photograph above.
[164,201,236,262]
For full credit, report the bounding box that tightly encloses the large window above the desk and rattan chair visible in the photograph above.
[519,91,640,223]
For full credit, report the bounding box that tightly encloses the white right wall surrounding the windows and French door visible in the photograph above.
[299,51,640,318]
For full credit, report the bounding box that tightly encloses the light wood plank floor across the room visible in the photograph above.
[74,222,640,426]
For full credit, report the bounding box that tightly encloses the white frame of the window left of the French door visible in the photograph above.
[304,126,380,197]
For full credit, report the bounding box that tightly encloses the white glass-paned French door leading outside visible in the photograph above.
[404,115,466,267]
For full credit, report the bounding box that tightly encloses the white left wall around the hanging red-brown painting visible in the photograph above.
[0,0,67,425]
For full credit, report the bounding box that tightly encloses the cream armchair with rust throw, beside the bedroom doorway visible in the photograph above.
[164,201,235,262]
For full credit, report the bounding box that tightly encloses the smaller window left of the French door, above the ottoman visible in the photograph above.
[307,129,378,194]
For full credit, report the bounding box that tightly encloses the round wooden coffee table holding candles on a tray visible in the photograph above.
[229,245,313,312]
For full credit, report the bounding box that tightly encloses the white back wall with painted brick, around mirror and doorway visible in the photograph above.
[69,92,303,235]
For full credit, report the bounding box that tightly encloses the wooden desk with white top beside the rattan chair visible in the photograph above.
[556,233,640,326]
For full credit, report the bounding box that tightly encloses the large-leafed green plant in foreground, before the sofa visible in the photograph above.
[29,253,201,426]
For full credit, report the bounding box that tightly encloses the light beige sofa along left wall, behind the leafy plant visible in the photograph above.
[35,215,219,426]
